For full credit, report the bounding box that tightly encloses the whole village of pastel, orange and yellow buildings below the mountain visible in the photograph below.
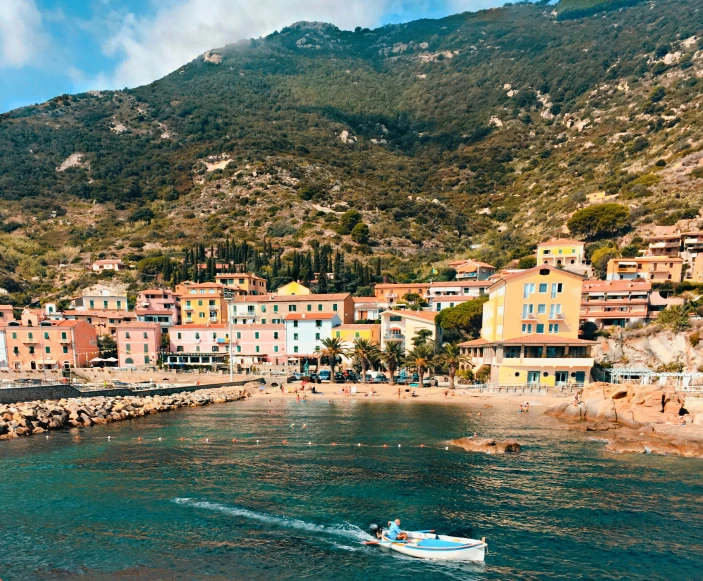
[0,233,703,387]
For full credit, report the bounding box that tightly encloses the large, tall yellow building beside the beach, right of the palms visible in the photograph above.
[460,265,594,386]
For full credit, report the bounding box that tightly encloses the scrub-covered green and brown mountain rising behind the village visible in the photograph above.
[0,0,703,296]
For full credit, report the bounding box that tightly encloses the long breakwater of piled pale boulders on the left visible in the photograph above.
[0,384,251,440]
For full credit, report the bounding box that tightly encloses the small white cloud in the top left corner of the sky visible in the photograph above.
[0,0,47,68]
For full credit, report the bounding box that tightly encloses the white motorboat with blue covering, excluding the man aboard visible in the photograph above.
[379,530,487,562]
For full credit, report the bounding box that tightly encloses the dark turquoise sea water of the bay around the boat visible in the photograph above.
[0,399,703,581]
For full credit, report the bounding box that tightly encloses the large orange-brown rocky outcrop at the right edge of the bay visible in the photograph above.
[546,383,703,458]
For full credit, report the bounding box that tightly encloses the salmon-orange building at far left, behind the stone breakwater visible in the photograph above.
[5,321,98,371]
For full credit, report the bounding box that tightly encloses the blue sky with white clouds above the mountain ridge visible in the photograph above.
[0,0,505,113]
